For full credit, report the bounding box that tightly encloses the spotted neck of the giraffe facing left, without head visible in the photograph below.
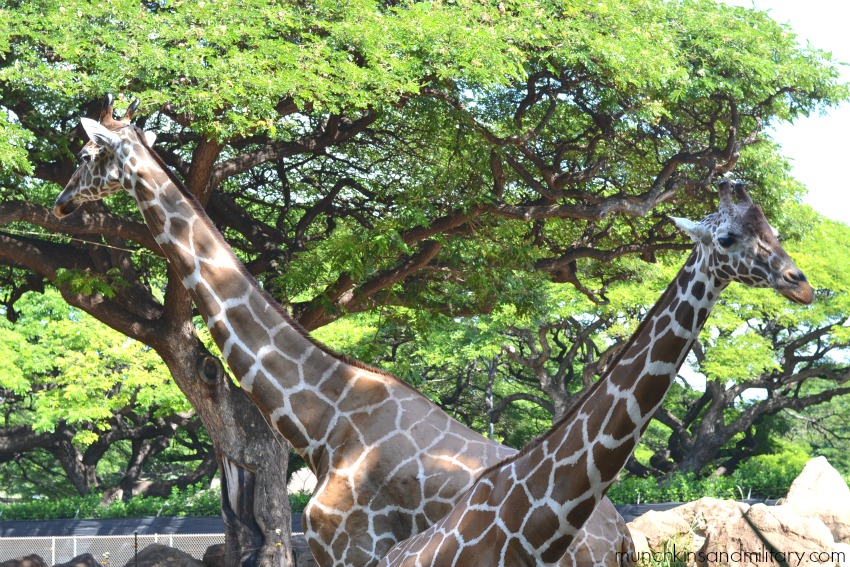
[127,133,374,470]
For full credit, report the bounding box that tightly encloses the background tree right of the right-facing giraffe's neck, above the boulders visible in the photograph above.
[653,215,850,474]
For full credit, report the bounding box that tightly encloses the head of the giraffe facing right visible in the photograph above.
[673,180,814,305]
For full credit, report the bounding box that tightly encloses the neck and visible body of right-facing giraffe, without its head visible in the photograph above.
[390,246,725,567]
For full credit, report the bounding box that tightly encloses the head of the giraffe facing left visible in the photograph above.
[53,95,155,218]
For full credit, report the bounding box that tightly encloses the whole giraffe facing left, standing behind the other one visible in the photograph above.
[54,97,632,567]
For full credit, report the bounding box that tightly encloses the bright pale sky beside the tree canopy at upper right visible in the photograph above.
[725,0,850,224]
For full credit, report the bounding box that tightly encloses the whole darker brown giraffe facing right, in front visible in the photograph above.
[379,181,814,567]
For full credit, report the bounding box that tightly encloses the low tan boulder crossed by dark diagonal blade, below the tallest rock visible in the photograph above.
[696,504,835,567]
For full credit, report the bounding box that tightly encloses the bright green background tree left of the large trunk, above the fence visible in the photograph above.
[0,290,215,499]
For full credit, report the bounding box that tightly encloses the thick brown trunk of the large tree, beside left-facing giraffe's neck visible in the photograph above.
[156,280,295,567]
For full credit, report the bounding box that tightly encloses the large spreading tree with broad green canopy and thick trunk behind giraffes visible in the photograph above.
[0,0,846,564]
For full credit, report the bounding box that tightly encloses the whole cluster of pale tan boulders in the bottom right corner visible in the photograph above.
[628,457,850,567]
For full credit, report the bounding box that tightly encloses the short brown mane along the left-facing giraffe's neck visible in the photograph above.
[129,125,418,388]
